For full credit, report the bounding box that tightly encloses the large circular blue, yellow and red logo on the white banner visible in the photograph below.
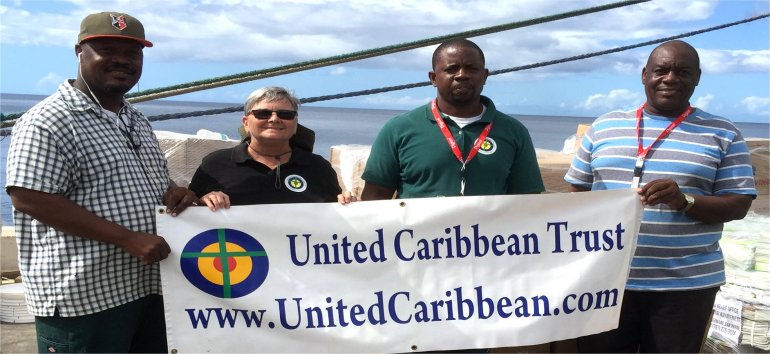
[180,229,269,299]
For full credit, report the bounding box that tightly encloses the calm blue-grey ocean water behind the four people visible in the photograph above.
[0,94,770,225]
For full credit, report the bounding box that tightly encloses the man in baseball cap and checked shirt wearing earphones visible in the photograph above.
[6,12,196,353]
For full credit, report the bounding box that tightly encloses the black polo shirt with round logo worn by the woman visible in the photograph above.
[189,143,341,205]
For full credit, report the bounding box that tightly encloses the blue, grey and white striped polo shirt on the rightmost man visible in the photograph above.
[564,108,757,291]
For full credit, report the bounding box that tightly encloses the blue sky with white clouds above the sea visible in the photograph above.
[0,0,770,123]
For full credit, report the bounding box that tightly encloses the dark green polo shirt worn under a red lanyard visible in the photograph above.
[361,96,545,198]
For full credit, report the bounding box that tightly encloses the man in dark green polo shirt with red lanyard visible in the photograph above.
[361,39,545,200]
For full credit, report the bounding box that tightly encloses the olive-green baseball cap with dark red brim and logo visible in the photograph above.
[78,12,152,47]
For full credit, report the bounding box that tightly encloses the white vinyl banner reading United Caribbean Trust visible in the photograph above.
[158,189,642,353]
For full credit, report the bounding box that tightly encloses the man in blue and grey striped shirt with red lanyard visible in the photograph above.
[564,41,757,353]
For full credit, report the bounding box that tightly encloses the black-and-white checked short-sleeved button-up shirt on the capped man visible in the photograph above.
[6,82,169,317]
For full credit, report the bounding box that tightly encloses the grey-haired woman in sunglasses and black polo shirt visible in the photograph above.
[189,87,345,211]
